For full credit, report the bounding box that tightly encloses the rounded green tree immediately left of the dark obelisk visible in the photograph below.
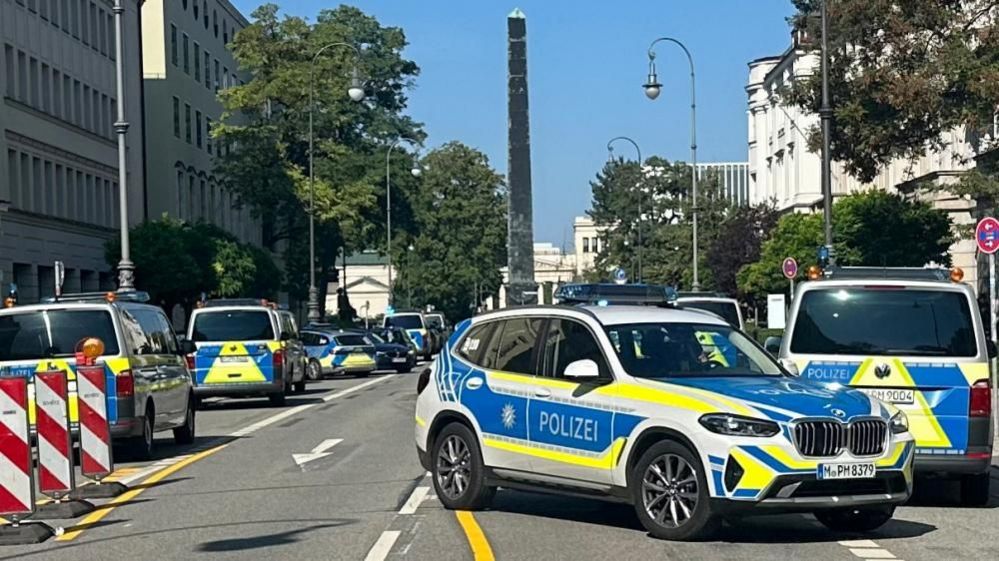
[392,142,507,321]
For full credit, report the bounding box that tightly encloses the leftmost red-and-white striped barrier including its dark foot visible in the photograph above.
[0,376,54,545]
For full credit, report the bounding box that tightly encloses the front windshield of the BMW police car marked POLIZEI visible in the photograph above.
[606,323,782,378]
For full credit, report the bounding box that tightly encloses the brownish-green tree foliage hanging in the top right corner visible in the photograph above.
[785,0,999,181]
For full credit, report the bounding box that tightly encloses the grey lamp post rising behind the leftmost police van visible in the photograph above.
[113,0,135,292]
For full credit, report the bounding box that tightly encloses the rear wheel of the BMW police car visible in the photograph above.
[430,423,496,510]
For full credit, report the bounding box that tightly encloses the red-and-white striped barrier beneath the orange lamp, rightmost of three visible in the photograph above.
[76,365,114,481]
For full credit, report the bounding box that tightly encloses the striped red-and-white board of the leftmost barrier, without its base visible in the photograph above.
[0,377,35,522]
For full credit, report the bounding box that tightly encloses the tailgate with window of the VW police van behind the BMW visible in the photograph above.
[785,283,989,455]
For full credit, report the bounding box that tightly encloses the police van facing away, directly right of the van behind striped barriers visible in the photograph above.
[187,299,306,405]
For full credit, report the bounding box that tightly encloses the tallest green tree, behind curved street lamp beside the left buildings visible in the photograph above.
[214,4,423,303]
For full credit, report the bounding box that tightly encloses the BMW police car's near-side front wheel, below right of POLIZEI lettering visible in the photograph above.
[629,440,721,541]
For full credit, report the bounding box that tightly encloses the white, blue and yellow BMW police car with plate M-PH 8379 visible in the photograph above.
[416,306,913,539]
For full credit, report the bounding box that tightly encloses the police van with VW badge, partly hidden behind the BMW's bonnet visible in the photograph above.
[779,267,994,505]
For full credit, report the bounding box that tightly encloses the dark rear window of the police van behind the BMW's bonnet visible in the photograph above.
[790,287,978,357]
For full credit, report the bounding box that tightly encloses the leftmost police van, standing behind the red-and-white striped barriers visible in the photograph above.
[0,292,195,459]
